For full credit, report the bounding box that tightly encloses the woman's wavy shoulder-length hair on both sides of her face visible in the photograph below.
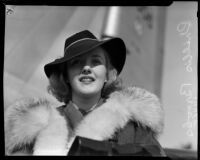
[47,47,122,104]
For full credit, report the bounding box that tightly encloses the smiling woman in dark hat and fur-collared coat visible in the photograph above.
[5,30,165,156]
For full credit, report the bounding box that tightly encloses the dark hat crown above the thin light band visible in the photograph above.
[64,30,97,50]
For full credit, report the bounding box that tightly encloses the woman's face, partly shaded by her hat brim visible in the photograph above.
[67,47,107,97]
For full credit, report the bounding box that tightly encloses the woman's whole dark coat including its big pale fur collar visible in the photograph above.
[5,87,165,156]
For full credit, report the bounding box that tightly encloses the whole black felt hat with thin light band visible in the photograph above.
[44,30,126,78]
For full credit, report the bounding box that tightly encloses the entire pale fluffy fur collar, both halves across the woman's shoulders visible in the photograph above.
[5,87,164,155]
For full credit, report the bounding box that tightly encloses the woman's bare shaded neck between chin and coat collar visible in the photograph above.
[72,92,101,111]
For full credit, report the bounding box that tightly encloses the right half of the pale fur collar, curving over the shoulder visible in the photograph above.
[76,87,164,140]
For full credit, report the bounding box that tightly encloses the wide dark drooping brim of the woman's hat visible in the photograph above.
[44,38,126,78]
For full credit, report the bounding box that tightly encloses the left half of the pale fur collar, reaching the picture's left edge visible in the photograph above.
[5,98,68,155]
